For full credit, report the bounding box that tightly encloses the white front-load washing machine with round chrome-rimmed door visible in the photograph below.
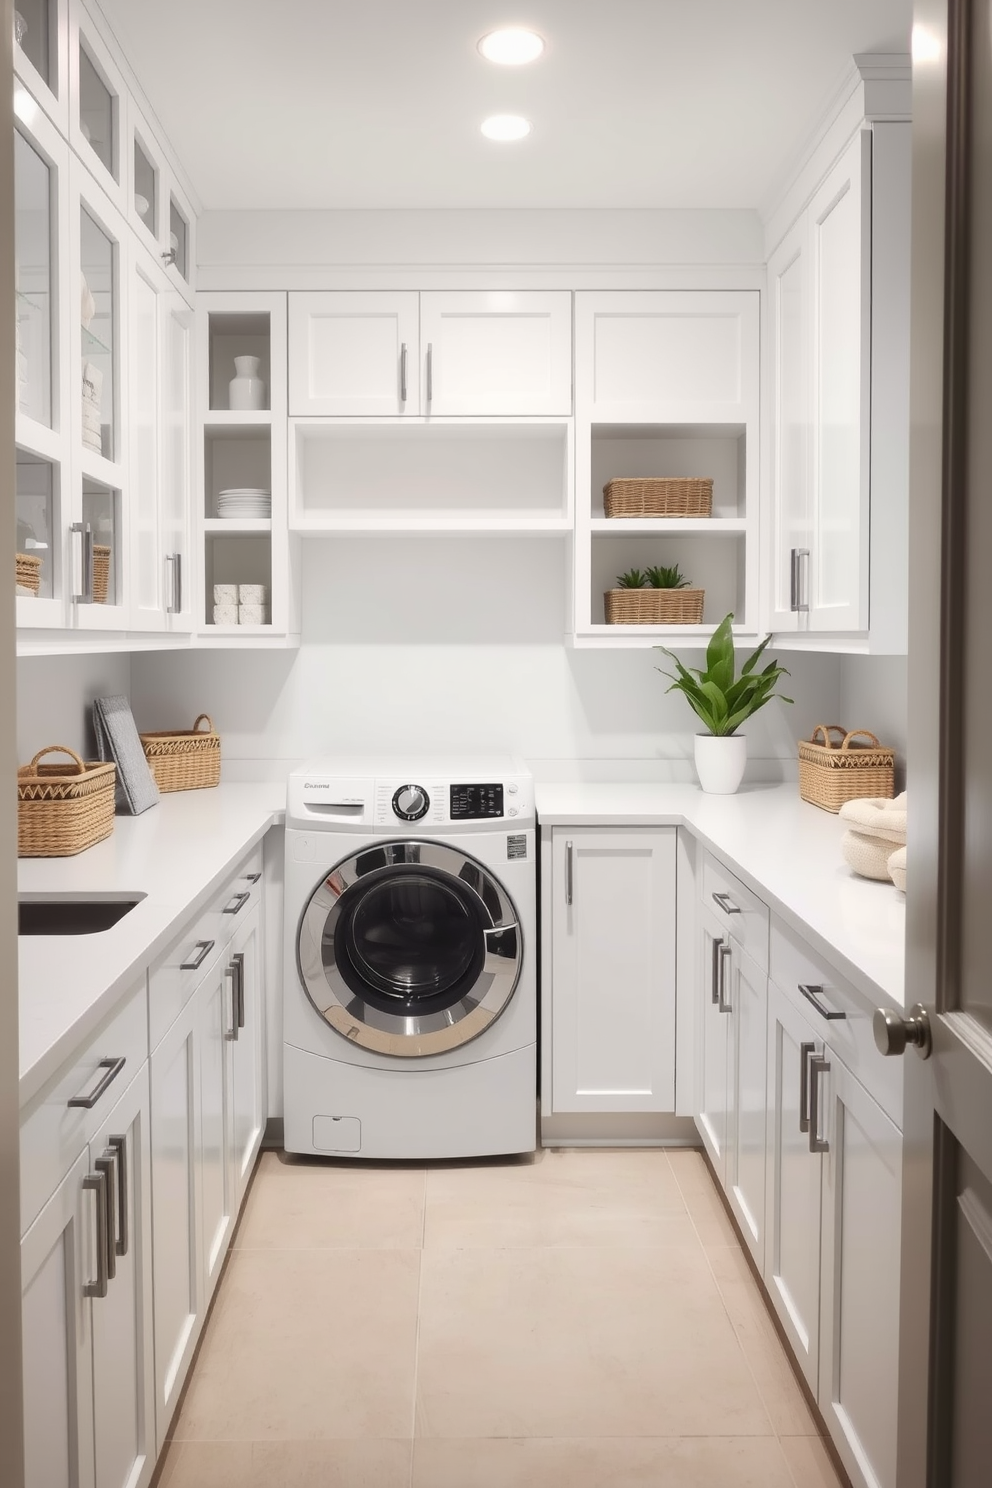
[284,759,537,1158]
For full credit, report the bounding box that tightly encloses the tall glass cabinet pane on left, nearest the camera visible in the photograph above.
[13,131,52,429]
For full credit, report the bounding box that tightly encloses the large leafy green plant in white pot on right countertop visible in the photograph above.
[659,615,793,796]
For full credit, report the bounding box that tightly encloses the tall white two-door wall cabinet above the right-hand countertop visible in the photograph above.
[767,122,910,650]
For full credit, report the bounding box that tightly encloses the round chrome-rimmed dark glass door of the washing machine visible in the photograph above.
[297,842,522,1056]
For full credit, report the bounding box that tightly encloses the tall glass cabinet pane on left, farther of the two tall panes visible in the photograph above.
[80,207,116,460]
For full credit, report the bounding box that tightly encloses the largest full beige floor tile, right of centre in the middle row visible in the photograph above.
[416,1247,772,1437]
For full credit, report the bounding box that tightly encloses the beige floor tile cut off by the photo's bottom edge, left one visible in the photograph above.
[155,1439,413,1488]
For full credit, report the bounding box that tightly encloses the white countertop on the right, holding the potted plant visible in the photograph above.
[535,784,906,1007]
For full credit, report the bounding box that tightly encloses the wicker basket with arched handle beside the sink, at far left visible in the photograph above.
[18,744,117,857]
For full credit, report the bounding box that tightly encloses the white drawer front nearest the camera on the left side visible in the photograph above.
[21,976,149,1235]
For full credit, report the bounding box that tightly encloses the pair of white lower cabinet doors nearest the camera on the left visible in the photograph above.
[21,1064,158,1488]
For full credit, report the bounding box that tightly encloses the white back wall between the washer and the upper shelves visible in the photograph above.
[131,536,840,780]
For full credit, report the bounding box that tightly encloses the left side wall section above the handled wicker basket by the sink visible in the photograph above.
[18,653,131,765]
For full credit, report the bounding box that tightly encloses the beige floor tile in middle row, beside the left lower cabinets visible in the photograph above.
[174,1250,421,1440]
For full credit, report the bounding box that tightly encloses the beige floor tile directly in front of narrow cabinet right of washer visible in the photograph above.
[424,1150,699,1248]
